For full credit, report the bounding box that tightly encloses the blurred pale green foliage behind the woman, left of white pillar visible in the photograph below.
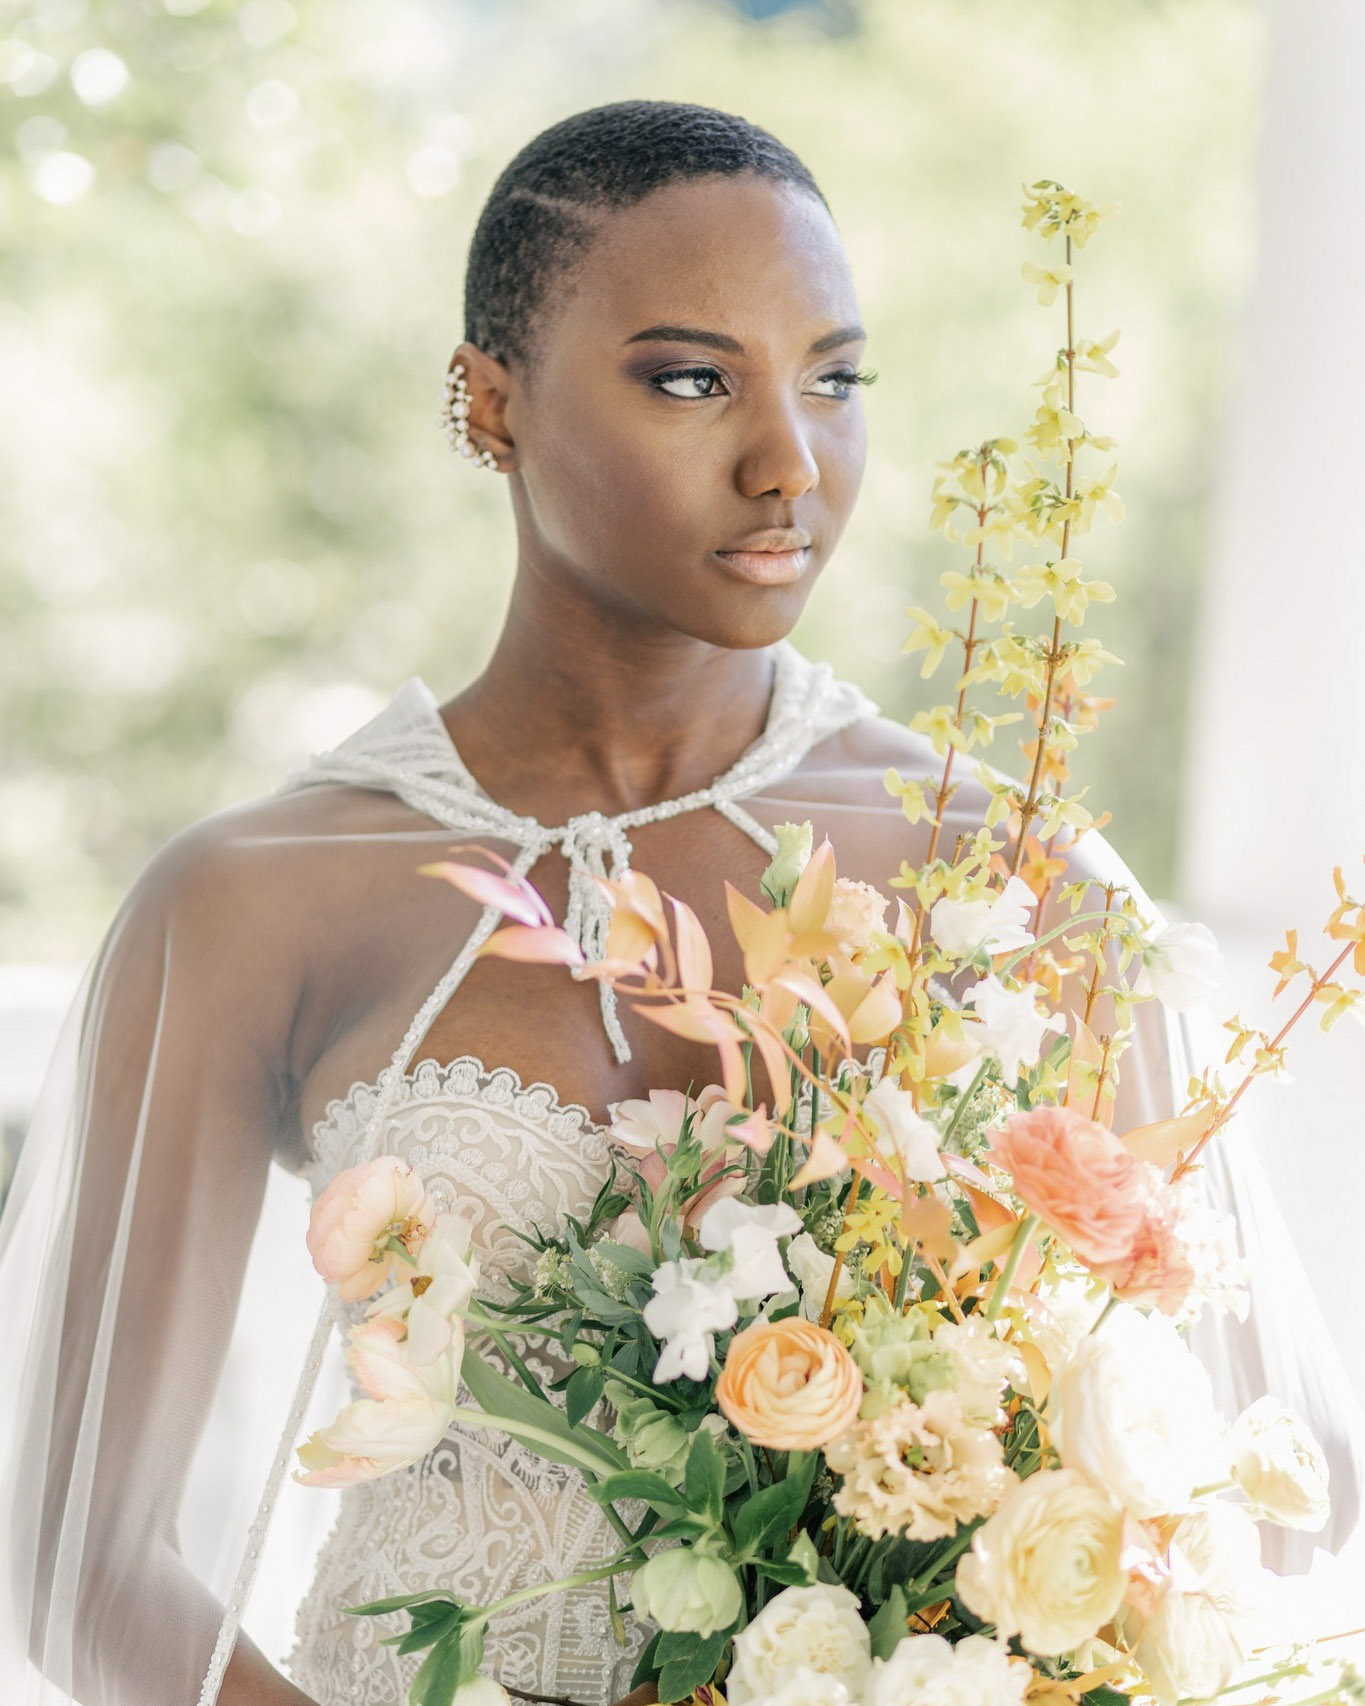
[0,0,1264,960]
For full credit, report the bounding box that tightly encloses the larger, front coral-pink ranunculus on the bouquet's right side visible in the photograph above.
[986,1107,1148,1268]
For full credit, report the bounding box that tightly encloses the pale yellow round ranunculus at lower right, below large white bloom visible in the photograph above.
[957,1469,1128,1658]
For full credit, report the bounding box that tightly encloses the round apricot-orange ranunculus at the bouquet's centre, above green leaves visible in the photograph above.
[715,1317,863,1452]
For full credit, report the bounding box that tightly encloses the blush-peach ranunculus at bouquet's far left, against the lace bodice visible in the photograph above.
[307,1155,437,1303]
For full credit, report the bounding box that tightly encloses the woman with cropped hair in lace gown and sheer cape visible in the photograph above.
[0,102,1351,1706]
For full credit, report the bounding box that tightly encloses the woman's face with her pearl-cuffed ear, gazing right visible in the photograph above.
[462,172,867,647]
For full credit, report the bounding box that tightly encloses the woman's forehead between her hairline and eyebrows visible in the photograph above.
[551,172,858,350]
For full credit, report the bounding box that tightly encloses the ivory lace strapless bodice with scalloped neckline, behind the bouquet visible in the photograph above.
[287,1056,652,1706]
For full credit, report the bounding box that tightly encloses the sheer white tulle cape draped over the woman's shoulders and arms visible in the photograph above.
[0,658,1362,1706]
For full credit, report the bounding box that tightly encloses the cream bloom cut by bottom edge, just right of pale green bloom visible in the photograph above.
[725,1581,872,1706]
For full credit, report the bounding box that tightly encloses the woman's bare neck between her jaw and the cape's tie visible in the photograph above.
[442,575,773,822]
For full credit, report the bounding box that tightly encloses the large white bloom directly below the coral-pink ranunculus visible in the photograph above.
[1049,1303,1227,1517]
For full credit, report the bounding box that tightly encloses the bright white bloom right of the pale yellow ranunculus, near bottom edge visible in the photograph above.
[1119,1503,1275,1706]
